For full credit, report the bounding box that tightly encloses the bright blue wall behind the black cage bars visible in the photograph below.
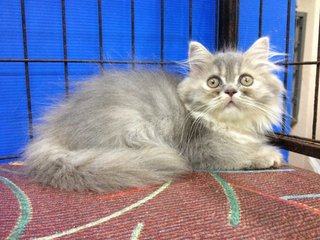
[0,0,294,161]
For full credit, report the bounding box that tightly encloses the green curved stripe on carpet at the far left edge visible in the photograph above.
[0,176,31,240]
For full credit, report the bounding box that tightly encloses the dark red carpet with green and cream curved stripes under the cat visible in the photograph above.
[0,162,320,239]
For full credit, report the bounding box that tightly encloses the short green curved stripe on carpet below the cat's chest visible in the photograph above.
[210,172,240,226]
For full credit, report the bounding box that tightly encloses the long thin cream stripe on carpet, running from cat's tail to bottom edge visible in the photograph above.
[35,181,171,240]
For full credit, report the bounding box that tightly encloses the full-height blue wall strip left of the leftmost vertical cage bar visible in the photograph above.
[0,0,28,157]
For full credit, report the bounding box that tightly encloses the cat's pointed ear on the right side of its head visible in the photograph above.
[245,37,270,61]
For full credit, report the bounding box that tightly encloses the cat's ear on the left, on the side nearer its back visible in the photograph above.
[188,41,212,73]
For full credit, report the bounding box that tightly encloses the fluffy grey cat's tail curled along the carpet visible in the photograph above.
[25,140,190,192]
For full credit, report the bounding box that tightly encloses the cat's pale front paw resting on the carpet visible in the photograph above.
[251,146,283,169]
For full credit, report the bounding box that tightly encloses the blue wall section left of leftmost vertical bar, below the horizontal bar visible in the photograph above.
[0,63,29,156]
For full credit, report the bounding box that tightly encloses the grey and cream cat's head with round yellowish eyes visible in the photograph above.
[178,37,285,133]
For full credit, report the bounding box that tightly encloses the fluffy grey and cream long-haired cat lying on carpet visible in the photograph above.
[24,37,285,193]
